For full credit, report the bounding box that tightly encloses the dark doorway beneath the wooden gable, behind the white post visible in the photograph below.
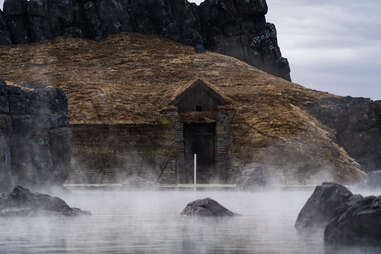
[183,123,216,183]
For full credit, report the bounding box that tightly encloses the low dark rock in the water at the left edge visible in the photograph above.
[0,186,90,217]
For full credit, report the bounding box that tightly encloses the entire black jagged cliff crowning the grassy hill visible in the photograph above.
[0,0,290,80]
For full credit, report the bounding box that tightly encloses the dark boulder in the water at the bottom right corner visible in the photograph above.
[324,196,381,246]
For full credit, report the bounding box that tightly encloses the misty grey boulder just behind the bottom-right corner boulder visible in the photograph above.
[295,183,358,230]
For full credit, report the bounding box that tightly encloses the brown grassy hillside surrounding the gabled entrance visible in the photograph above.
[0,34,364,182]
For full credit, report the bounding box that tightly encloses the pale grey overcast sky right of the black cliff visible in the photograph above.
[0,0,381,99]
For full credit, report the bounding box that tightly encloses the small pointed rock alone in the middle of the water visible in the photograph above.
[181,198,235,217]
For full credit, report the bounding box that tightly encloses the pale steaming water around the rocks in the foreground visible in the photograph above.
[0,191,381,254]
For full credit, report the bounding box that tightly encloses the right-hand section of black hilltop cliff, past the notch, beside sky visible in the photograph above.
[199,0,291,80]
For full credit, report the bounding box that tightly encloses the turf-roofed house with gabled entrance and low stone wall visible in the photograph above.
[72,79,235,184]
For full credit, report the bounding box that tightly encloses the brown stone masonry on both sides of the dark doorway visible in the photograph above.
[68,109,234,184]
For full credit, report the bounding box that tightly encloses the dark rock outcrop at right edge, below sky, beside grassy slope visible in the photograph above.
[308,97,381,171]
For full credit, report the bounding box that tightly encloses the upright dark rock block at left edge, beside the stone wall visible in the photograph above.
[0,78,71,191]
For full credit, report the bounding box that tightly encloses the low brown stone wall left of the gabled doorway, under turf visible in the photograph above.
[68,122,175,183]
